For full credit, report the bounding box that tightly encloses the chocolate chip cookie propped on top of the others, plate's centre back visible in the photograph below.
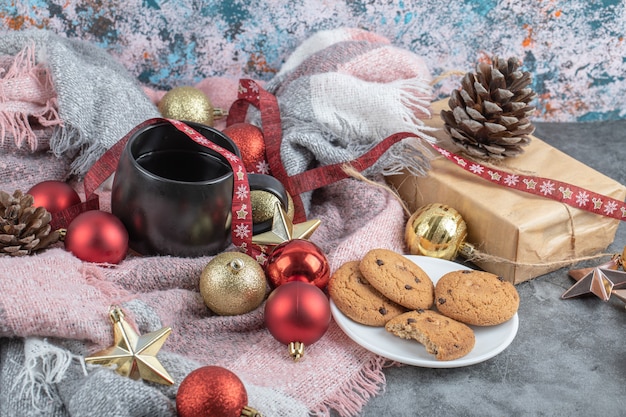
[359,249,434,310]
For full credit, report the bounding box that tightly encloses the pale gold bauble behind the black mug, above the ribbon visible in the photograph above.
[158,86,215,126]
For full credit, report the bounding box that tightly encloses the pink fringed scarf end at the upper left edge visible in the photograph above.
[0,44,63,152]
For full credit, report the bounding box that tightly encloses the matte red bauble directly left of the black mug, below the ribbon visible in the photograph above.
[65,210,128,264]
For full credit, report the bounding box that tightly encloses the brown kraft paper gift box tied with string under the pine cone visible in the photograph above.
[388,101,626,284]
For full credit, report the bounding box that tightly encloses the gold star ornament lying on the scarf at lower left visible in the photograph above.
[85,306,174,385]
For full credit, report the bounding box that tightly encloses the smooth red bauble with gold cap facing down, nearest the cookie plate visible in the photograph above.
[265,281,331,345]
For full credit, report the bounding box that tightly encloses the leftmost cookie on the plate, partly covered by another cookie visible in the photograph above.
[328,261,406,327]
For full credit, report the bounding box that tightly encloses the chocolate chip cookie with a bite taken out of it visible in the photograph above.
[385,310,476,361]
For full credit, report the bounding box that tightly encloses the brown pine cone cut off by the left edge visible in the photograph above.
[0,190,59,256]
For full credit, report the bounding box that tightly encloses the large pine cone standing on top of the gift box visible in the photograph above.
[441,57,536,159]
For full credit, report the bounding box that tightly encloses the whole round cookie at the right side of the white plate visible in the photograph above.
[435,270,519,326]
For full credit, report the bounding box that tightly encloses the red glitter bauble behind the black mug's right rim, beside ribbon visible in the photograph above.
[222,123,269,174]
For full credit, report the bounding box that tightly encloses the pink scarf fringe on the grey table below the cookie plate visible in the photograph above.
[311,355,391,417]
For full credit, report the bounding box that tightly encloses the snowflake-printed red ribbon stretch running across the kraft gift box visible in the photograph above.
[432,145,626,220]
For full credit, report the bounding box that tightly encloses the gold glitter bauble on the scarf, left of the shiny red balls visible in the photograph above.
[200,252,267,316]
